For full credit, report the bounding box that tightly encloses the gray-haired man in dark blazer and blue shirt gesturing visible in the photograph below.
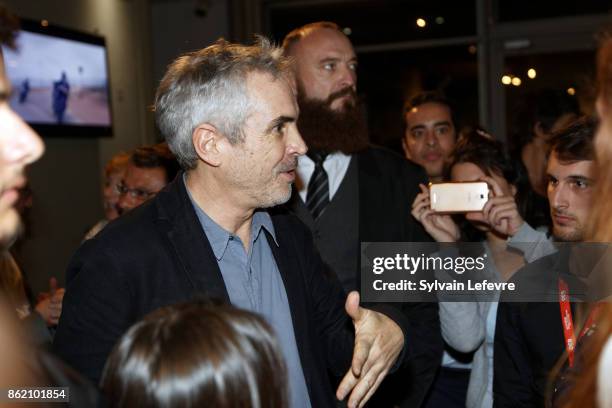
[56,41,406,407]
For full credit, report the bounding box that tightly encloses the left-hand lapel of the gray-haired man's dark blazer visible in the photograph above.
[155,173,230,303]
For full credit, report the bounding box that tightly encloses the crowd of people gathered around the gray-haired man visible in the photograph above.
[0,6,612,408]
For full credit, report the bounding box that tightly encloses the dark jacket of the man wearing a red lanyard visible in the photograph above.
[493,249,580,407]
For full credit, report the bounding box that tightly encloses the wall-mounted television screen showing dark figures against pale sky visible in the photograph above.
[2,20,112,137]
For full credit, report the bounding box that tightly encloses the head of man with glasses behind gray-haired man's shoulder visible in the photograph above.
[117,144,179,215]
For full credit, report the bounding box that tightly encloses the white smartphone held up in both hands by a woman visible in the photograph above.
[429,181,489,213]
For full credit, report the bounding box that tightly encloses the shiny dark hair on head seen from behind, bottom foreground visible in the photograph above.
[102,301,288,408]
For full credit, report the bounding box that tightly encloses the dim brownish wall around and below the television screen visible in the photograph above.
[4,0,153,293]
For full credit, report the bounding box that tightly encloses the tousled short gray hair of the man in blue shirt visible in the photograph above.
[154,37,289,170]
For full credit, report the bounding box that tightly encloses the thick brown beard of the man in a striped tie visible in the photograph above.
[297,86,369,154]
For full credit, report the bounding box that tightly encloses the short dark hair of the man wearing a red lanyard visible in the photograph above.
[548,116,597,163]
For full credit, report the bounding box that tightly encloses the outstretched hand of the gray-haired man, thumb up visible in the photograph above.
[336,291,404,408]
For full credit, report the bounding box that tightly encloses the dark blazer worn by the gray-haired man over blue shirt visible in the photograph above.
[54,175,411,407]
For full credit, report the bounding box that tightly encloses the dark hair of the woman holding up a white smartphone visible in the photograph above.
[446,126,535,241]
